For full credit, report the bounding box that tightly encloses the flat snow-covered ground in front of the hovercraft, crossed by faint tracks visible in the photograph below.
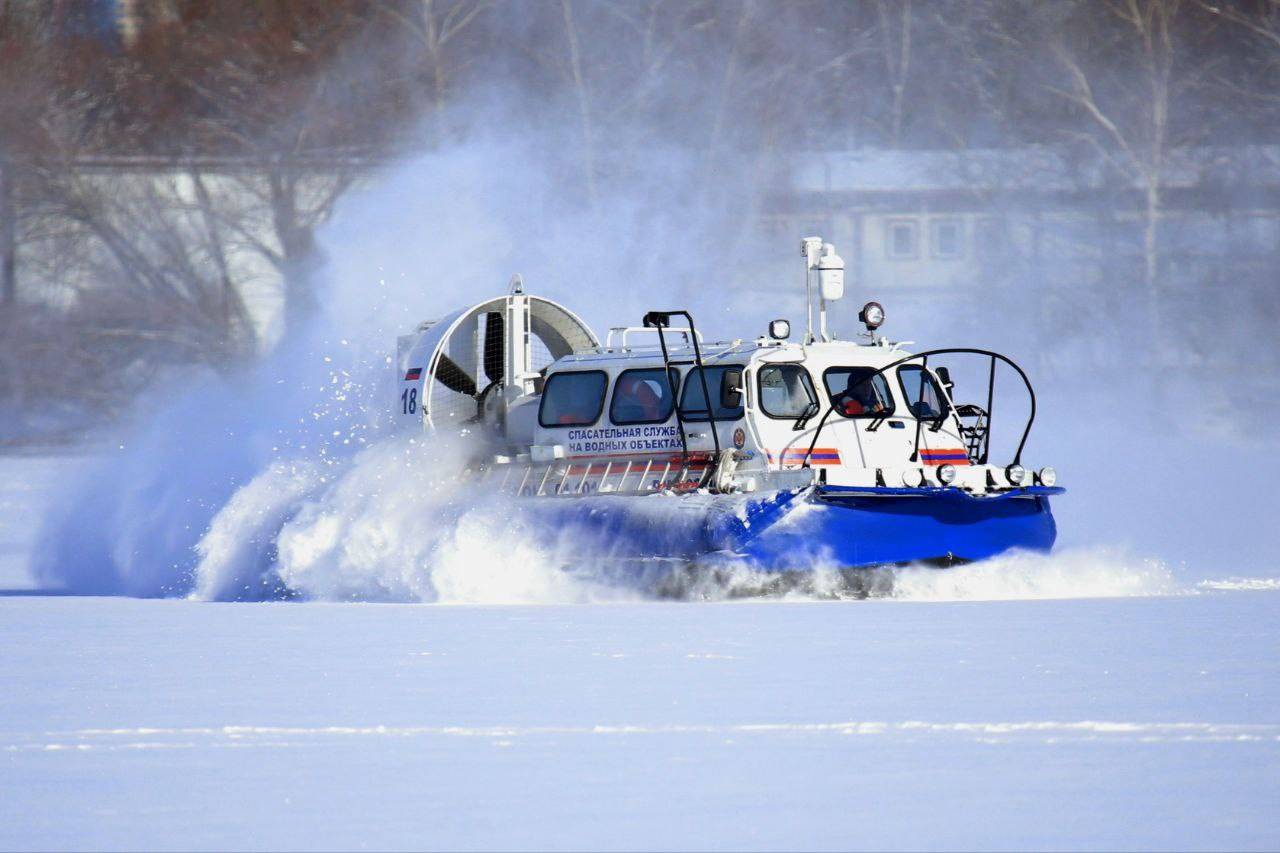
[0,450,1280,849]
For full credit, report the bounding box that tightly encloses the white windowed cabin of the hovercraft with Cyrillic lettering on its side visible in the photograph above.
[522,339,1018,492]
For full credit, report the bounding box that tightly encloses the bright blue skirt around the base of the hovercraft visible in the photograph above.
[524,487,1064,573]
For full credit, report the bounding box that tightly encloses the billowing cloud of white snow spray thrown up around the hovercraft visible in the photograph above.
[35,99,1277,602]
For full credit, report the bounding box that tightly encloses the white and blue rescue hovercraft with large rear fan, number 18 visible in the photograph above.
[396,237,1064,584]
